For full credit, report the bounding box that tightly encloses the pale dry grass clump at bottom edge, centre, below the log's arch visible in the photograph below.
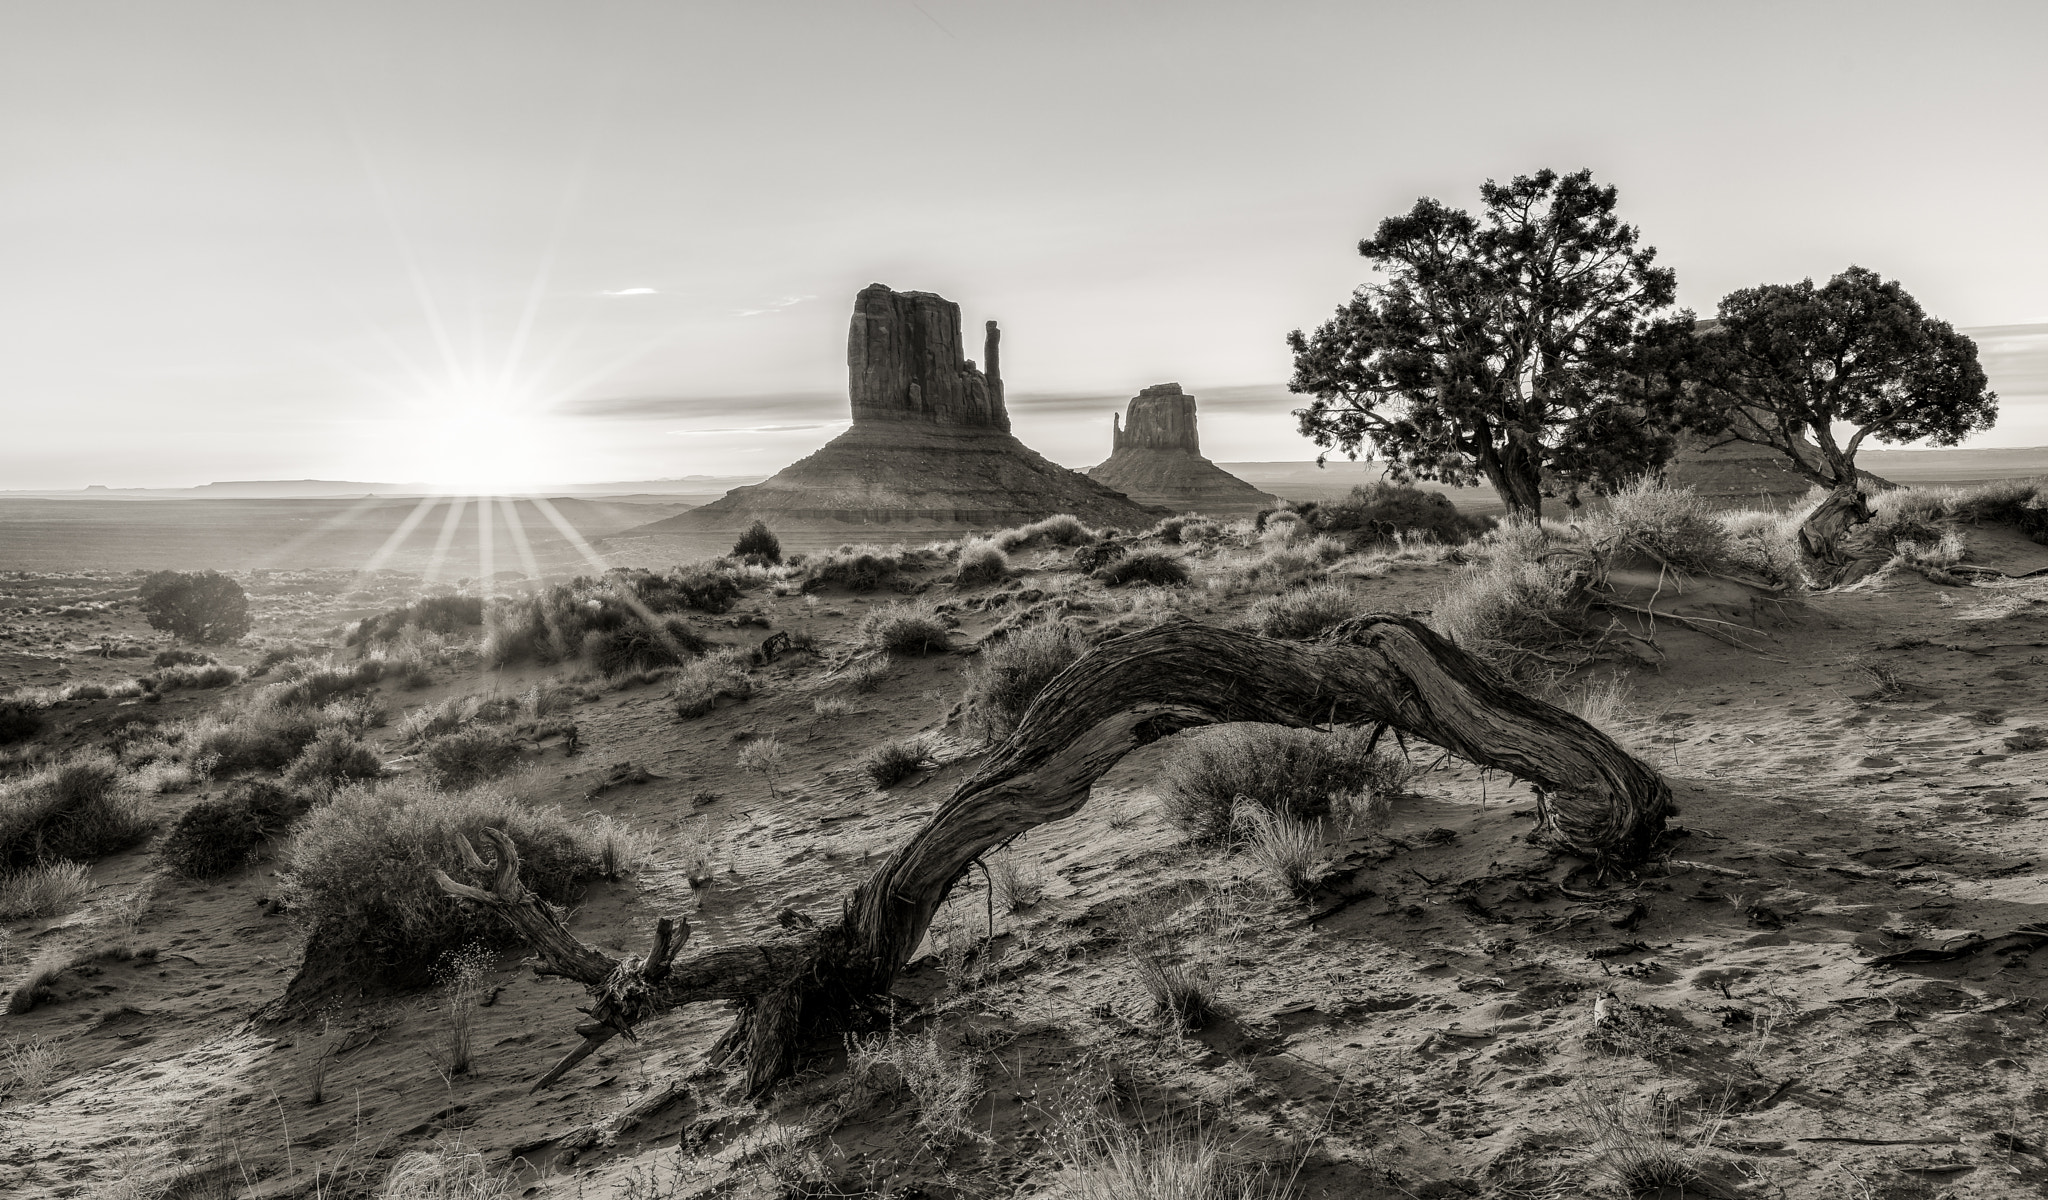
[1047,1118,1300,1200]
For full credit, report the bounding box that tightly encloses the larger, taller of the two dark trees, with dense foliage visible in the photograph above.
[1288,170,1692,514]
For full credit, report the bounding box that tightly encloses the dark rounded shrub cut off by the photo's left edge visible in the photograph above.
[0,749,150,870]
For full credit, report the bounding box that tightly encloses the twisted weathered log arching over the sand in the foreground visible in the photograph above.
[438,614,1675,1096]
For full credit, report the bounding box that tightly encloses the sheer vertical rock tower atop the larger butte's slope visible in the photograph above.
[846,283,1010,432]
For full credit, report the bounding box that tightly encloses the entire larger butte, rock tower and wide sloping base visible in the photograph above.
[637,283,1161,534]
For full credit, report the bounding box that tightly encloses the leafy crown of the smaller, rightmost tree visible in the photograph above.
[1698,266,1999,489]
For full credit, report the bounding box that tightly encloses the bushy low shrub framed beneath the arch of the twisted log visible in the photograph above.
[1159,725,1411,842]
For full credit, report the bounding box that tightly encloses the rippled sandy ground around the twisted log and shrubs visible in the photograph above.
[0,539,2048,1200]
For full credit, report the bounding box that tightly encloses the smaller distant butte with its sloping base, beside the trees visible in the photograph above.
[1087,383,1280,516]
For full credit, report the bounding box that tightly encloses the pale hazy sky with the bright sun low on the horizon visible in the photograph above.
[0,0,2048,489]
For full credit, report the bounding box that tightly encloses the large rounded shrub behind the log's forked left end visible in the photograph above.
[285,778,600,983]
